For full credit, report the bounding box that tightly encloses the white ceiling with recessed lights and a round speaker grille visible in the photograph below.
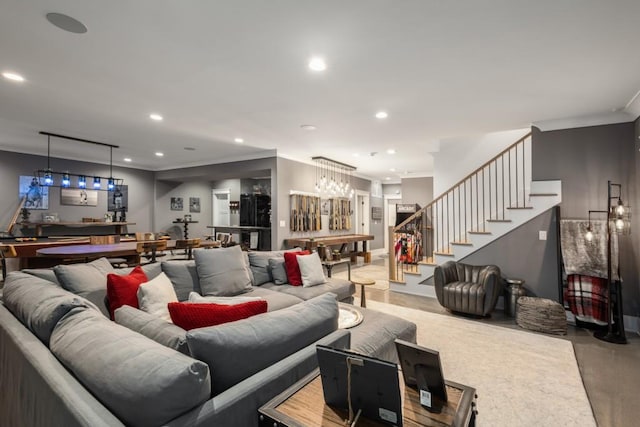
[0,0,640,179]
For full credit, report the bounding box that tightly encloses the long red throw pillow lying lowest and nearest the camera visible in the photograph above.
[169,301,267,331]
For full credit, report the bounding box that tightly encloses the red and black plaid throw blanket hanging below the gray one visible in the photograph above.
[564,274,607,325]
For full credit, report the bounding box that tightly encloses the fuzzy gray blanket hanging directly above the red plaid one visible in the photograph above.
[560,219,619,280]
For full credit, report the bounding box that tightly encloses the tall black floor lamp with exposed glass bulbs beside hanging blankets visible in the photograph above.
[585,181,631,344]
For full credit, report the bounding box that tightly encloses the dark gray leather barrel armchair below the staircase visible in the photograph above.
[433,261,502,316]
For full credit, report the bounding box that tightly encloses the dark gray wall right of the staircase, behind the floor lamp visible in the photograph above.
[529,120,640,316]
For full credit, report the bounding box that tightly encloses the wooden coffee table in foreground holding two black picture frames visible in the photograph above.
[258,369,476,427]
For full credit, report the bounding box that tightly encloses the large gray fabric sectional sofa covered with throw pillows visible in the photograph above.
[0,253,416,426]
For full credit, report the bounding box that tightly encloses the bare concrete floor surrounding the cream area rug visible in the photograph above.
[334,259,640,427]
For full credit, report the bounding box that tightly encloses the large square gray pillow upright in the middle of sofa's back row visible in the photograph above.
[194,246,251,296]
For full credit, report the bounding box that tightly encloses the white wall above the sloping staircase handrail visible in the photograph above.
[433,128,530,197]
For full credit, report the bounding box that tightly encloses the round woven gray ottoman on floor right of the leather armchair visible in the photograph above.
[516,297,567,335]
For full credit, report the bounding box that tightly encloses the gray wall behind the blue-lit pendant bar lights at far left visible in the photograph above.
[0,151,155,235]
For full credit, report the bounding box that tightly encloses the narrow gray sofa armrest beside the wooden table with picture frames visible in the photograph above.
[162,329,351,427]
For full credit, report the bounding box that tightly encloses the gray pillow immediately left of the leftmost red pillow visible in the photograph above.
[53,258,114,316]
